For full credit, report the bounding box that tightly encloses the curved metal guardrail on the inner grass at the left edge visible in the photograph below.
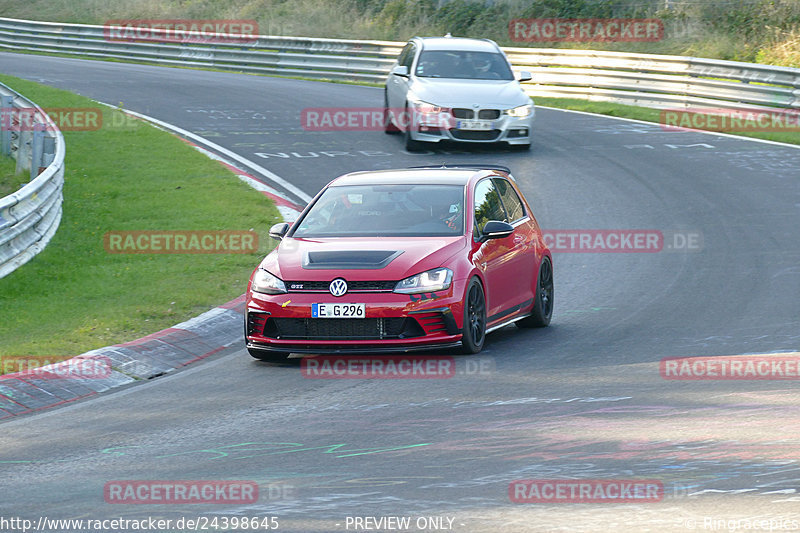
[0,84,65,278]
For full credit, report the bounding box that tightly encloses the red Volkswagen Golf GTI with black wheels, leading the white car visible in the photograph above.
[245,166,553,360]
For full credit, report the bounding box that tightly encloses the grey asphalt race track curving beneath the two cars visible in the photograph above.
[0,53,800,532]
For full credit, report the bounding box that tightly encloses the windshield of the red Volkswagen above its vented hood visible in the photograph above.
[291,184,464,237]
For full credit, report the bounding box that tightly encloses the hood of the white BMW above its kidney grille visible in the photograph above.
[410,78,531,109]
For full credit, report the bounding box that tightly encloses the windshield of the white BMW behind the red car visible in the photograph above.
[416,50,514,80]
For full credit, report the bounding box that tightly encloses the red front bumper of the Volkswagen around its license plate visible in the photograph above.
[245,281,463,353]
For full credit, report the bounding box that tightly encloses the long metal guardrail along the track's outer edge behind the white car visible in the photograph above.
[0,18,800,112]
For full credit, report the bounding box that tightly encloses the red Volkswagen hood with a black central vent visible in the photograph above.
[261,235,467,281]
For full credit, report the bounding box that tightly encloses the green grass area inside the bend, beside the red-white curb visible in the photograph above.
[0,75,279,357]
